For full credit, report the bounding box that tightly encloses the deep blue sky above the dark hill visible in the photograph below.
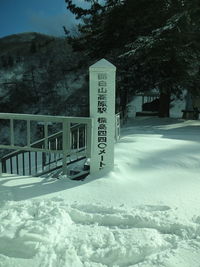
[0,0,84,37]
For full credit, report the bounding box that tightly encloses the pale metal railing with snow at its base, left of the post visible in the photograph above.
[0,113,93,178]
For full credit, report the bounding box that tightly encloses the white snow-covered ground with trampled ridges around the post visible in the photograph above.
[0,118,200,267]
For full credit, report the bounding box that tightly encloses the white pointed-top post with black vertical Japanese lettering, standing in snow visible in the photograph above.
[89,59,116,174]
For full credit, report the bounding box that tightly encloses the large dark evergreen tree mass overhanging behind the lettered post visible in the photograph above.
[66,0,200,116]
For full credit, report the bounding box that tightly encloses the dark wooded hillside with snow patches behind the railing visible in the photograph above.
[0,32,88,116]
